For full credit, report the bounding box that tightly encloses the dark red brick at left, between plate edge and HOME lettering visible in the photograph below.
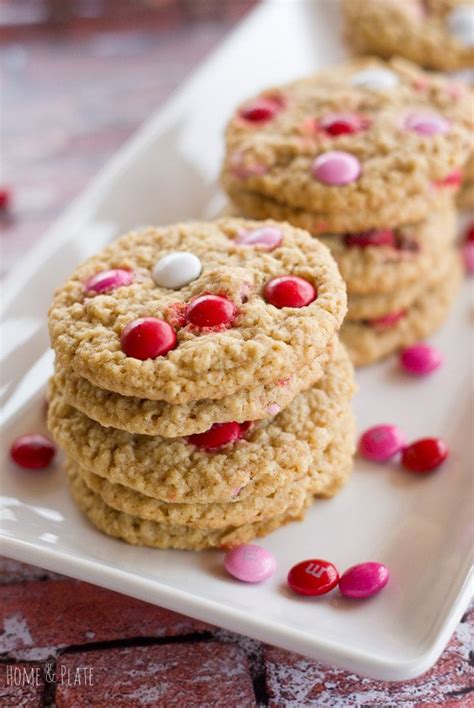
[0,579,208,658]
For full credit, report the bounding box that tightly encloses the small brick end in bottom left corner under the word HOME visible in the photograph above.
[0,663,45,708]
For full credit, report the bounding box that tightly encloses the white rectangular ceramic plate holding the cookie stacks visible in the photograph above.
[1,0,474,680]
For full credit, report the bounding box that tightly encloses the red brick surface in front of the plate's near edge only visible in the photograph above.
[0,559,474,708]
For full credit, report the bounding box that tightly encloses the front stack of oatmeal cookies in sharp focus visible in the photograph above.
[48,218,354,549]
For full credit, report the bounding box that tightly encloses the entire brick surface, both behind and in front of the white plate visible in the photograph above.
[0,0,474,708]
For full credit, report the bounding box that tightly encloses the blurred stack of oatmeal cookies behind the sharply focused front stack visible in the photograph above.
[222,58,473,365]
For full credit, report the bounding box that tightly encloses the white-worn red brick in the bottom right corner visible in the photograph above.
[263,605,474,708]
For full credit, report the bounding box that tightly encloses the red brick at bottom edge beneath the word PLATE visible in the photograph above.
[56,642,256,708]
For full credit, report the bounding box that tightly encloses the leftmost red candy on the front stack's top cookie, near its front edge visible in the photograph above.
[120,317,176,360]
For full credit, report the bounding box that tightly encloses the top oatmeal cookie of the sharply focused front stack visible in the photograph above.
[49,219,346,404]
